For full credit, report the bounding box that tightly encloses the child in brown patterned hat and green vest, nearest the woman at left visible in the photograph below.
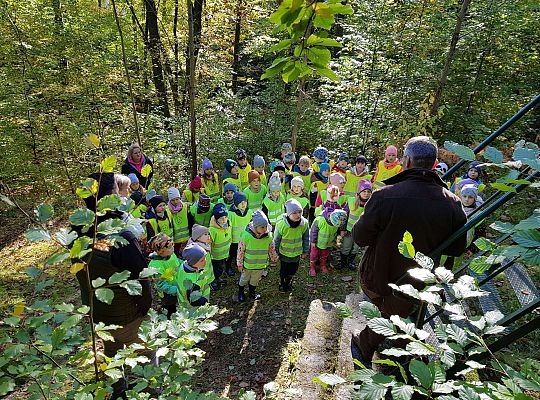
[148,232,181,318]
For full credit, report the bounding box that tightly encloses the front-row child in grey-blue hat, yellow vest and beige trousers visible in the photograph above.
[236,210,278,302]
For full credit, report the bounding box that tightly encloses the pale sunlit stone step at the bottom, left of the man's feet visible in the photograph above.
[293,299,341,400]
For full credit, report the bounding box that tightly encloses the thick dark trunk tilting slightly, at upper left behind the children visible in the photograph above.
[144,0,171,118]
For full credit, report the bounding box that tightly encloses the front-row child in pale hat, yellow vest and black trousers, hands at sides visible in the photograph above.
[274,199,309,292]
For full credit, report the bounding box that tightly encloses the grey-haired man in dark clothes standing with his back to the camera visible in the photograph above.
[351,136,467,365]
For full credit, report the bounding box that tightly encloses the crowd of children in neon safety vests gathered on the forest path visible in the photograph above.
[119,143,490,314]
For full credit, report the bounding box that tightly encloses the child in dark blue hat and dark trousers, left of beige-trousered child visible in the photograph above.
[208,203,232,288]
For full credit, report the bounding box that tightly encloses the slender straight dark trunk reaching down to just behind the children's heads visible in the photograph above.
[187,0,197,178]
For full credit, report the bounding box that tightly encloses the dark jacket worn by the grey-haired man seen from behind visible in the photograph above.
[352,168,467,296]
